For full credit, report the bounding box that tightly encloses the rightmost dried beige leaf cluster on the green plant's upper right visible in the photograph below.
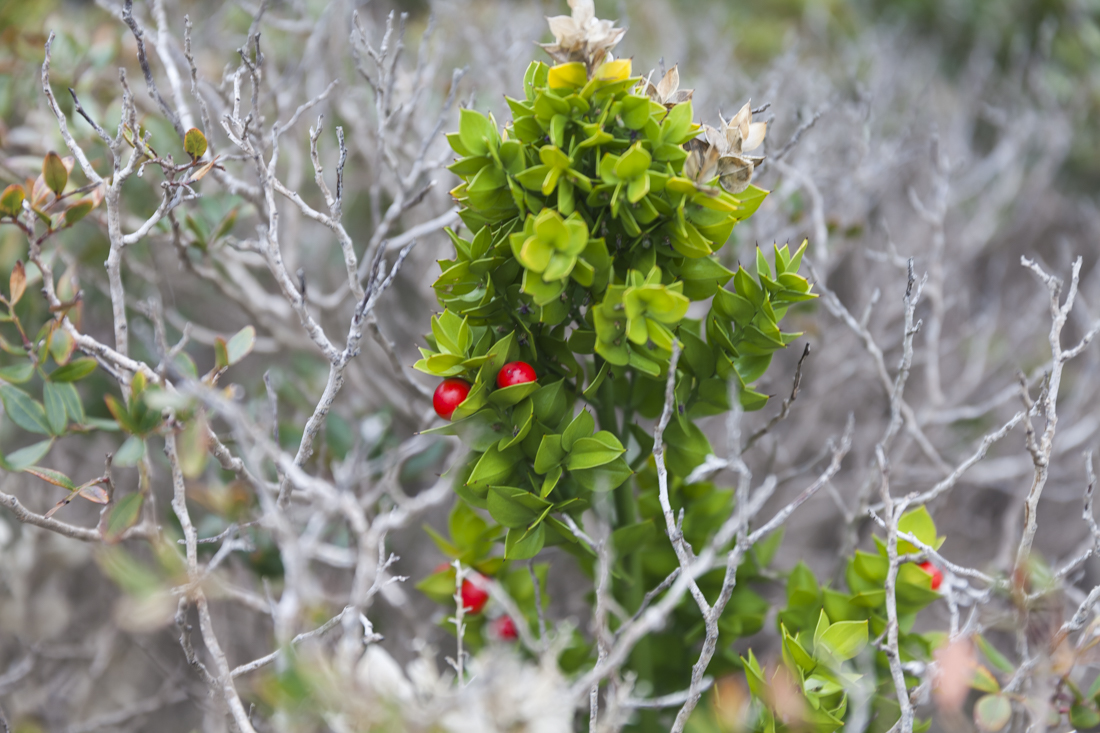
[684,102,768,194]
